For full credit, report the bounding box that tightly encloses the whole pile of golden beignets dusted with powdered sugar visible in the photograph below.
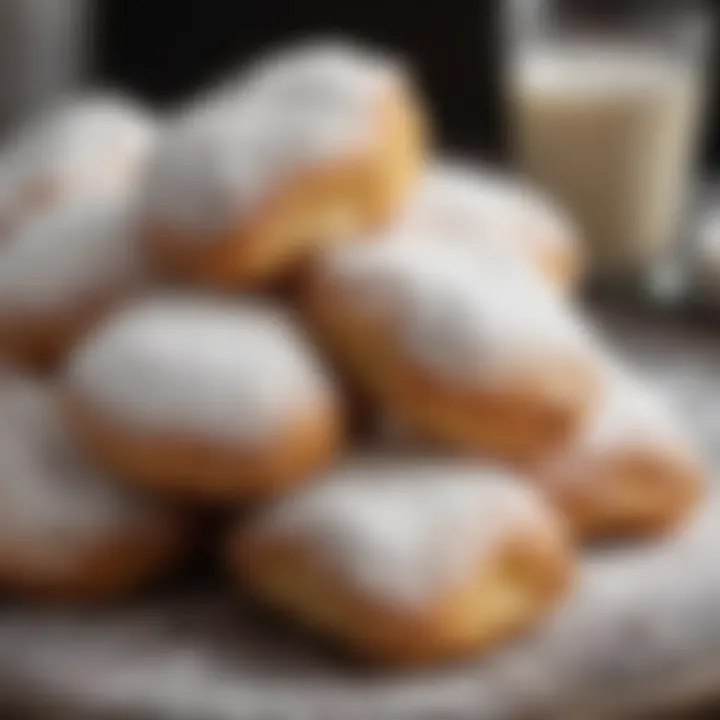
[0,41,703,664]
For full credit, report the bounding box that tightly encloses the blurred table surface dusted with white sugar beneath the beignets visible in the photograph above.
[0,313,720,720]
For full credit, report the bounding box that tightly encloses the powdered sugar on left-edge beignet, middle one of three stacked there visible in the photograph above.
[0,195,143,319]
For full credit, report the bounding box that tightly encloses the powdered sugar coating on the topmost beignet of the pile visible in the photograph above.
[142,43,397,237]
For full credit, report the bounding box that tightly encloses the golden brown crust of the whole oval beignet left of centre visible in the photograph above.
[66,398,344,501]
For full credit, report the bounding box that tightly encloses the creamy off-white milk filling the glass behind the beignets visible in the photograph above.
[509,43,701,272]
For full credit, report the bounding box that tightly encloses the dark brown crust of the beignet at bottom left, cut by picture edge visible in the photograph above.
[0,515,192,604]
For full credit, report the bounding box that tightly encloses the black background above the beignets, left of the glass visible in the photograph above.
[94,0,720,171]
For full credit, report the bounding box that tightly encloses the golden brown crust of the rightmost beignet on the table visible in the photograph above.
[539,445,703,540]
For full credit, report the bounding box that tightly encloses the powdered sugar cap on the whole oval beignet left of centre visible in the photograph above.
[69,296,330,444]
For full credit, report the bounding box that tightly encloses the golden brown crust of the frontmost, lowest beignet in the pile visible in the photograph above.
[229,526,574,666]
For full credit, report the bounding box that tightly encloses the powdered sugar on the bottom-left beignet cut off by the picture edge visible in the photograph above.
[0,372,167,572]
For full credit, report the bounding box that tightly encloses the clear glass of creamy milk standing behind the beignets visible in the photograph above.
[506,0,709,288]
